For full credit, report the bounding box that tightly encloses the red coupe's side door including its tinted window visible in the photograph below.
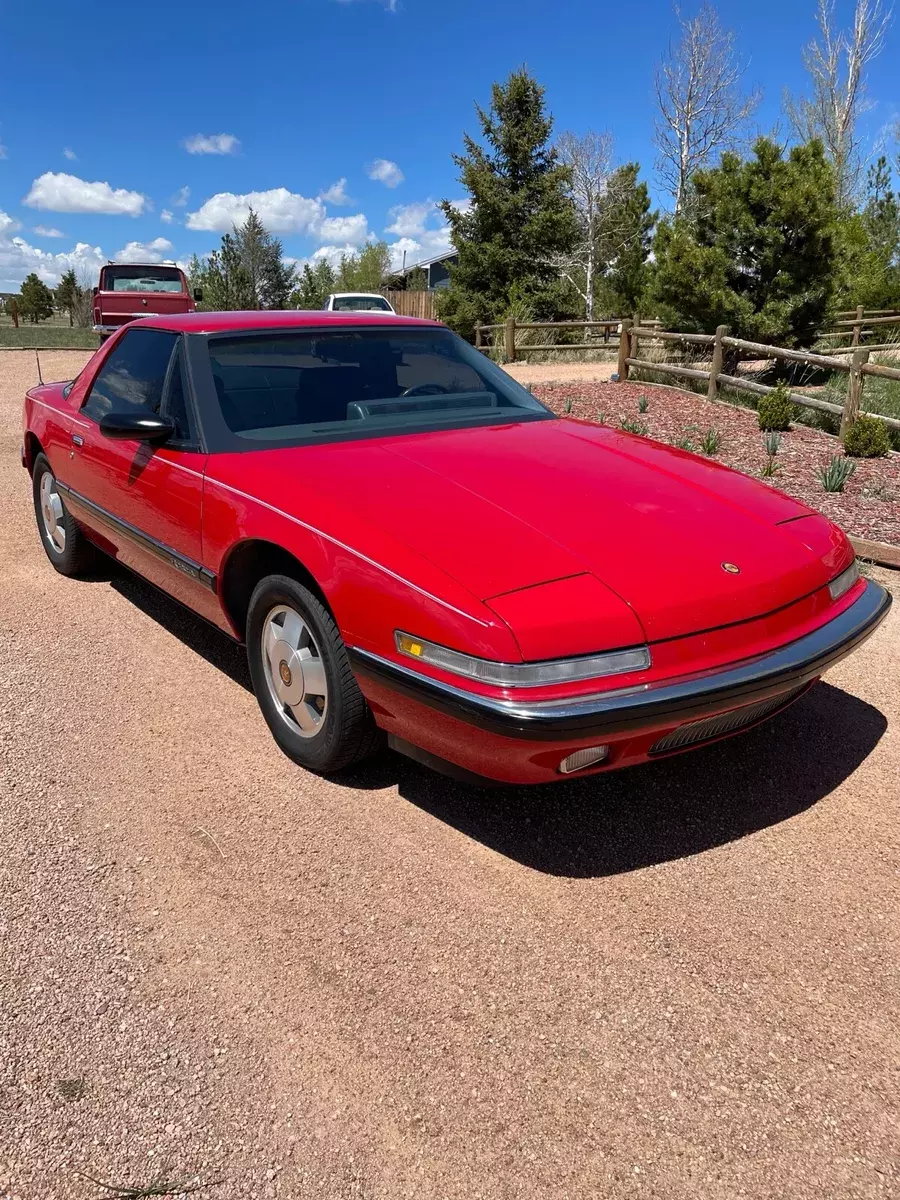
[66,328,211,612]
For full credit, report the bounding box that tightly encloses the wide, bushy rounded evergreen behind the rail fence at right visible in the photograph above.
[649,138,839,347]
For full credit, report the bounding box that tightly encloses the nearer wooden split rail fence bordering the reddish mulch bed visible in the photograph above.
[618,317,900,434]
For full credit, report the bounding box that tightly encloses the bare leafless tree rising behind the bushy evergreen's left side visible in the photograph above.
[654,4,760,212]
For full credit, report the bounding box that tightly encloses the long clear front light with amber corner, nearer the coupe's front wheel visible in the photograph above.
[394,630,650,688]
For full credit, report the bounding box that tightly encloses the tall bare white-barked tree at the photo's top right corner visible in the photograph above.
[785,0,892,204]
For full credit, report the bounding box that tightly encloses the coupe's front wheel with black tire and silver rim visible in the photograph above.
[246,575,382,774]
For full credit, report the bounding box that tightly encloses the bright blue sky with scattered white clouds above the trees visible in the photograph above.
[0,0,900,290]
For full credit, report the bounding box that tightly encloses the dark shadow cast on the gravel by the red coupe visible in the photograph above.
[110,572,887,878]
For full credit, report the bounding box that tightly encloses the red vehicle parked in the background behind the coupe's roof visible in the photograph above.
[94,263,203,341]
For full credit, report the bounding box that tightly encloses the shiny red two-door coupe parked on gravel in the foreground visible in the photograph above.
[23,312,890,784]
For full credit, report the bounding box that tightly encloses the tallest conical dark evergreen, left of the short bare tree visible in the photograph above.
[439,67,578,336]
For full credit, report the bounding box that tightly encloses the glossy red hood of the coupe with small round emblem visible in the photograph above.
[252,420,847,641]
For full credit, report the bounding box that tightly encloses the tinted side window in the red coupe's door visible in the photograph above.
[82,329,179,421]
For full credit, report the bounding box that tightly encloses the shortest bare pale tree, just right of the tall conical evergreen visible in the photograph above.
[554,131,613,320]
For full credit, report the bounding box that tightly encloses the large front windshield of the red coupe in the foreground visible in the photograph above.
[208,326,552,449]
